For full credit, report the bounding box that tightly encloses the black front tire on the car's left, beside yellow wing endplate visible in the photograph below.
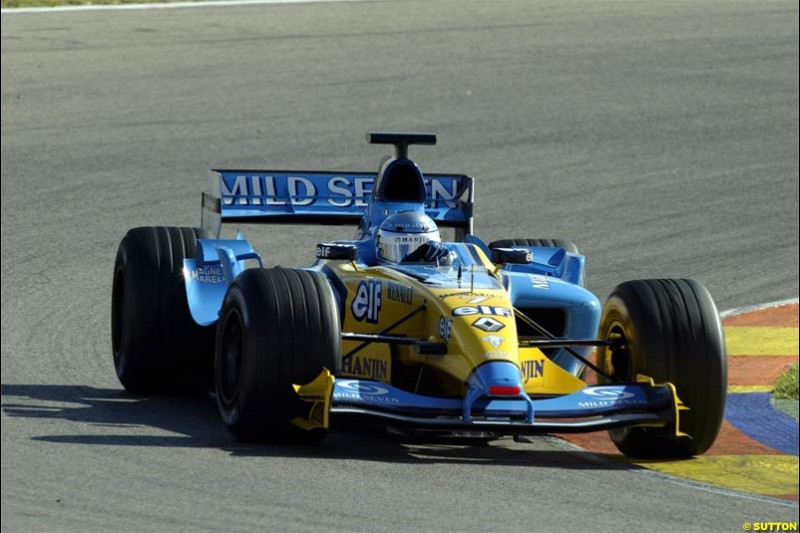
[214,268,341,443]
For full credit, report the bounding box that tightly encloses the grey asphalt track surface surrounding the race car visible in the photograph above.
[2,1,798,531]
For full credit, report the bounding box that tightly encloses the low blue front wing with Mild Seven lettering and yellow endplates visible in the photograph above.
[296,371,686,436]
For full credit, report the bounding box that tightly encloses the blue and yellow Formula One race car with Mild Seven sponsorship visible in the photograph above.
[111,133,727,457]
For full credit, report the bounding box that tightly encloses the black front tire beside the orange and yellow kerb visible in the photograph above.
[597,279,728,458]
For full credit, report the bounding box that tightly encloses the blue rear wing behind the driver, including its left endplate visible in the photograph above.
[201,170,475,236]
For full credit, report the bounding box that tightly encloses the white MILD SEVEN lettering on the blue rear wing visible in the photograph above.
[220,172,460,209]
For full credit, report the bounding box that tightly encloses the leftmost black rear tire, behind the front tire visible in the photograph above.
[111,227,214,393]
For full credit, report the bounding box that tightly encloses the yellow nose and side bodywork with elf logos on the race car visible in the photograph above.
[328,250,586,396]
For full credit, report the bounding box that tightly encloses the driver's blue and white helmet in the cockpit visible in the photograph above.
[376,211,442,263]
